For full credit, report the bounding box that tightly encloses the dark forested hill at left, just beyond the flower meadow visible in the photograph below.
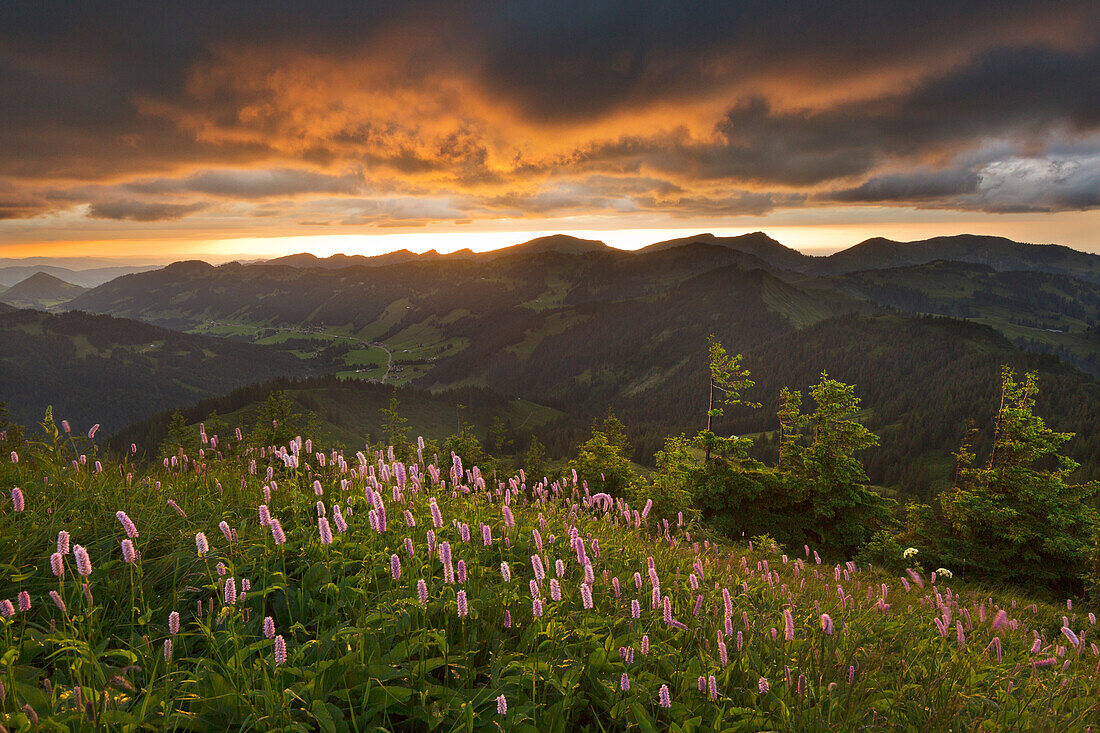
[0,310,311,431]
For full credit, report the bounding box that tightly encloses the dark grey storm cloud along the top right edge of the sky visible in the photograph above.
[483,0,1100,119]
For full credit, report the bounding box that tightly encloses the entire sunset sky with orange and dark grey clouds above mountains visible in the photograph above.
[0,0,1100,262]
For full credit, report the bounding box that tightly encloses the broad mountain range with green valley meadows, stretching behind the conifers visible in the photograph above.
[0,232,1100,495]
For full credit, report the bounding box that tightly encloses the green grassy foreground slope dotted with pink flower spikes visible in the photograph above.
[0,431,1100,732]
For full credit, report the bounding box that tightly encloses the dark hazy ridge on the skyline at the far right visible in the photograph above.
[812,234,1100,283]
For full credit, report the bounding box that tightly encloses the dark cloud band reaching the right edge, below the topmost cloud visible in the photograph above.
[573,40,1100,187]
